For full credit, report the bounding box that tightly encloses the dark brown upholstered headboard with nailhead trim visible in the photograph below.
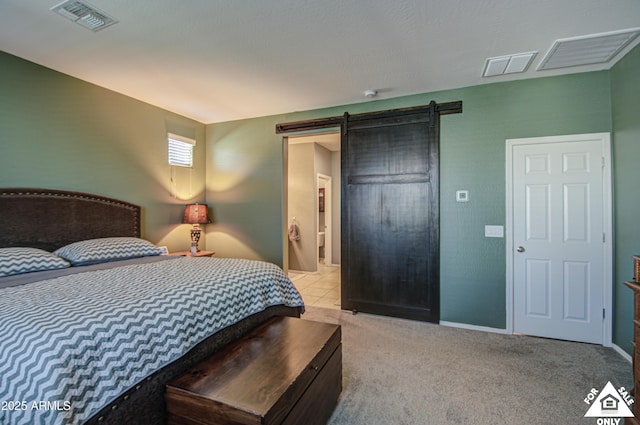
[0,188,140,251]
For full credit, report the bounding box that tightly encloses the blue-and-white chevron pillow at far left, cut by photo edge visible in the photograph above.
[0,248,70,277]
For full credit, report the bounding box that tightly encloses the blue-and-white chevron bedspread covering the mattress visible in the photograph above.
[0,258,303,425]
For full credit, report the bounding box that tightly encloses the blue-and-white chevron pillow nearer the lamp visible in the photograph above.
[53,237,161,266]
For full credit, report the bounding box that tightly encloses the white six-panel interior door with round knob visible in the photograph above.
[507,134,610,344]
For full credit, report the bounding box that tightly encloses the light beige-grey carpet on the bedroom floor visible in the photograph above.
[302,307,632,425]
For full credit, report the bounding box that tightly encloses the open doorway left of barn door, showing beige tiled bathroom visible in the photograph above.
[283,131,341,309]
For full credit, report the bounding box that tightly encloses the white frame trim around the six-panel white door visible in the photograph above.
[505,133,613,347]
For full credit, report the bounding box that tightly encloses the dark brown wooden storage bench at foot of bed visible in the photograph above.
[165,317,342,425]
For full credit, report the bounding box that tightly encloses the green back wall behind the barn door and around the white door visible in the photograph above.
[206,71,611,328]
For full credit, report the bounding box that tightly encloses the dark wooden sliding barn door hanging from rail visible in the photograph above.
[341,102,439,322]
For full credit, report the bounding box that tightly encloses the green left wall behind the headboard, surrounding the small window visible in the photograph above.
[0,52,205,250]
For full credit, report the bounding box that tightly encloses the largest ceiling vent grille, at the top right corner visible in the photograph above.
[538,28,640,71]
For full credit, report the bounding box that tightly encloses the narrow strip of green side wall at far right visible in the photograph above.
[610,47,640,353]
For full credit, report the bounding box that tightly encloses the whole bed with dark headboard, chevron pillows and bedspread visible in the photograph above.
[0,188,304,424]
